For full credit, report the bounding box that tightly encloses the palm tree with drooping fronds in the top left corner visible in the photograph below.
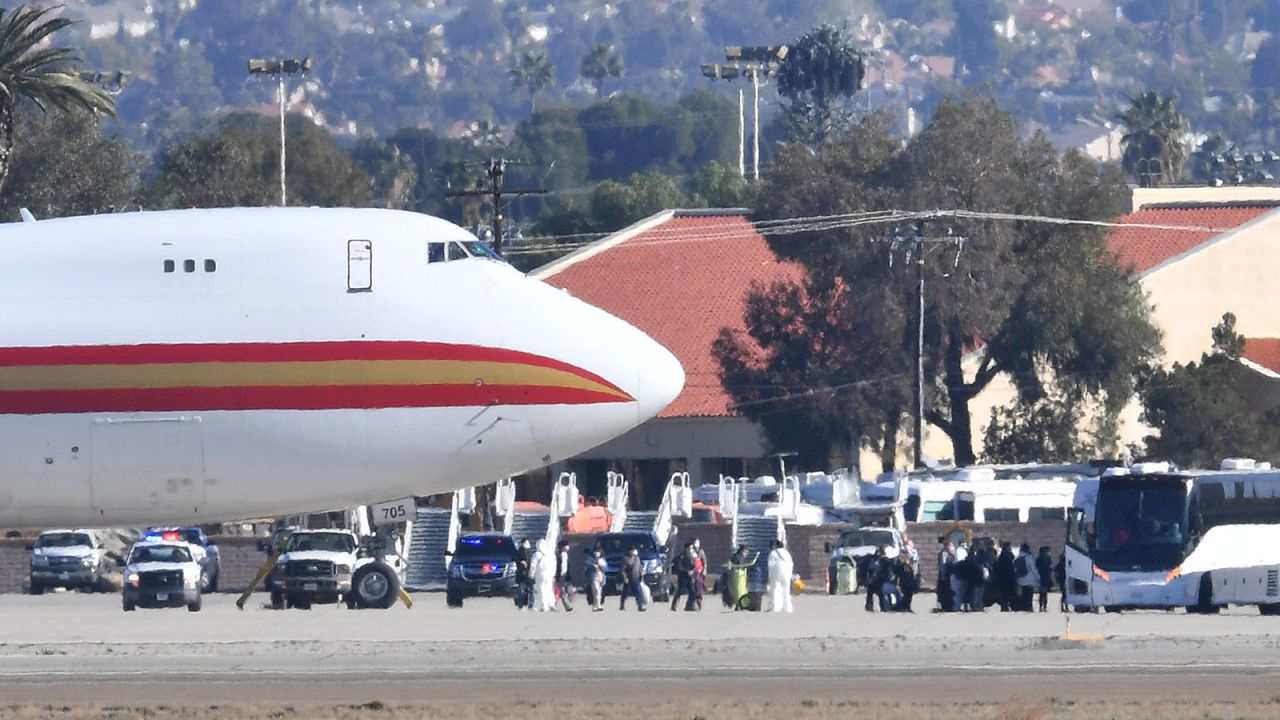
[0,5,115,188]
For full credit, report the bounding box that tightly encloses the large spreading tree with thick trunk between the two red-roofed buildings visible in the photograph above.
[728,96,1158,464]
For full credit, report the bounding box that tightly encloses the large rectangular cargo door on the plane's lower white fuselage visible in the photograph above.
[90,418,205,514]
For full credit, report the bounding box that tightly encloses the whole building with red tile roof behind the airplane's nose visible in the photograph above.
[531,210,803,503]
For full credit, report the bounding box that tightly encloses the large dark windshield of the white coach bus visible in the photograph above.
[1093,478,1187,571]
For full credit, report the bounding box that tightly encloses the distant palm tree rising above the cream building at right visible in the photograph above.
[1116,91,1187,187]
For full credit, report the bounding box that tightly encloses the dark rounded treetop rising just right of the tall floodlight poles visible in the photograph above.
[778,24,863,142]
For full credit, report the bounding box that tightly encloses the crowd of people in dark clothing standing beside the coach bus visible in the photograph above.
[937,538,1066,612]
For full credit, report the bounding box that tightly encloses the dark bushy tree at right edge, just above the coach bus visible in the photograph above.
[1139,313,1280,468]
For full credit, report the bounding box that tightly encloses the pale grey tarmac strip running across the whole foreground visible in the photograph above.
[0,593,1280,706]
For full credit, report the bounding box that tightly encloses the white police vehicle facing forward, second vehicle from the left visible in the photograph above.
[122,533,201,612]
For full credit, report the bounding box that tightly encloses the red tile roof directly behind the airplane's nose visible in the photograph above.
[543,211,801,418]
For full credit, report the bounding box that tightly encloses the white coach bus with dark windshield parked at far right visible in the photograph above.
[1066,460,1280,615]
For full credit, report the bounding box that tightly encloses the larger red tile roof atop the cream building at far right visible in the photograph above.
[1107,202,1275,274]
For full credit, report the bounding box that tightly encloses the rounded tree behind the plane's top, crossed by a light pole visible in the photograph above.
[143,115,371,208]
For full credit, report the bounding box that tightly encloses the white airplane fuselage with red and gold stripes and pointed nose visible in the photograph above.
[0,209,684,527]
